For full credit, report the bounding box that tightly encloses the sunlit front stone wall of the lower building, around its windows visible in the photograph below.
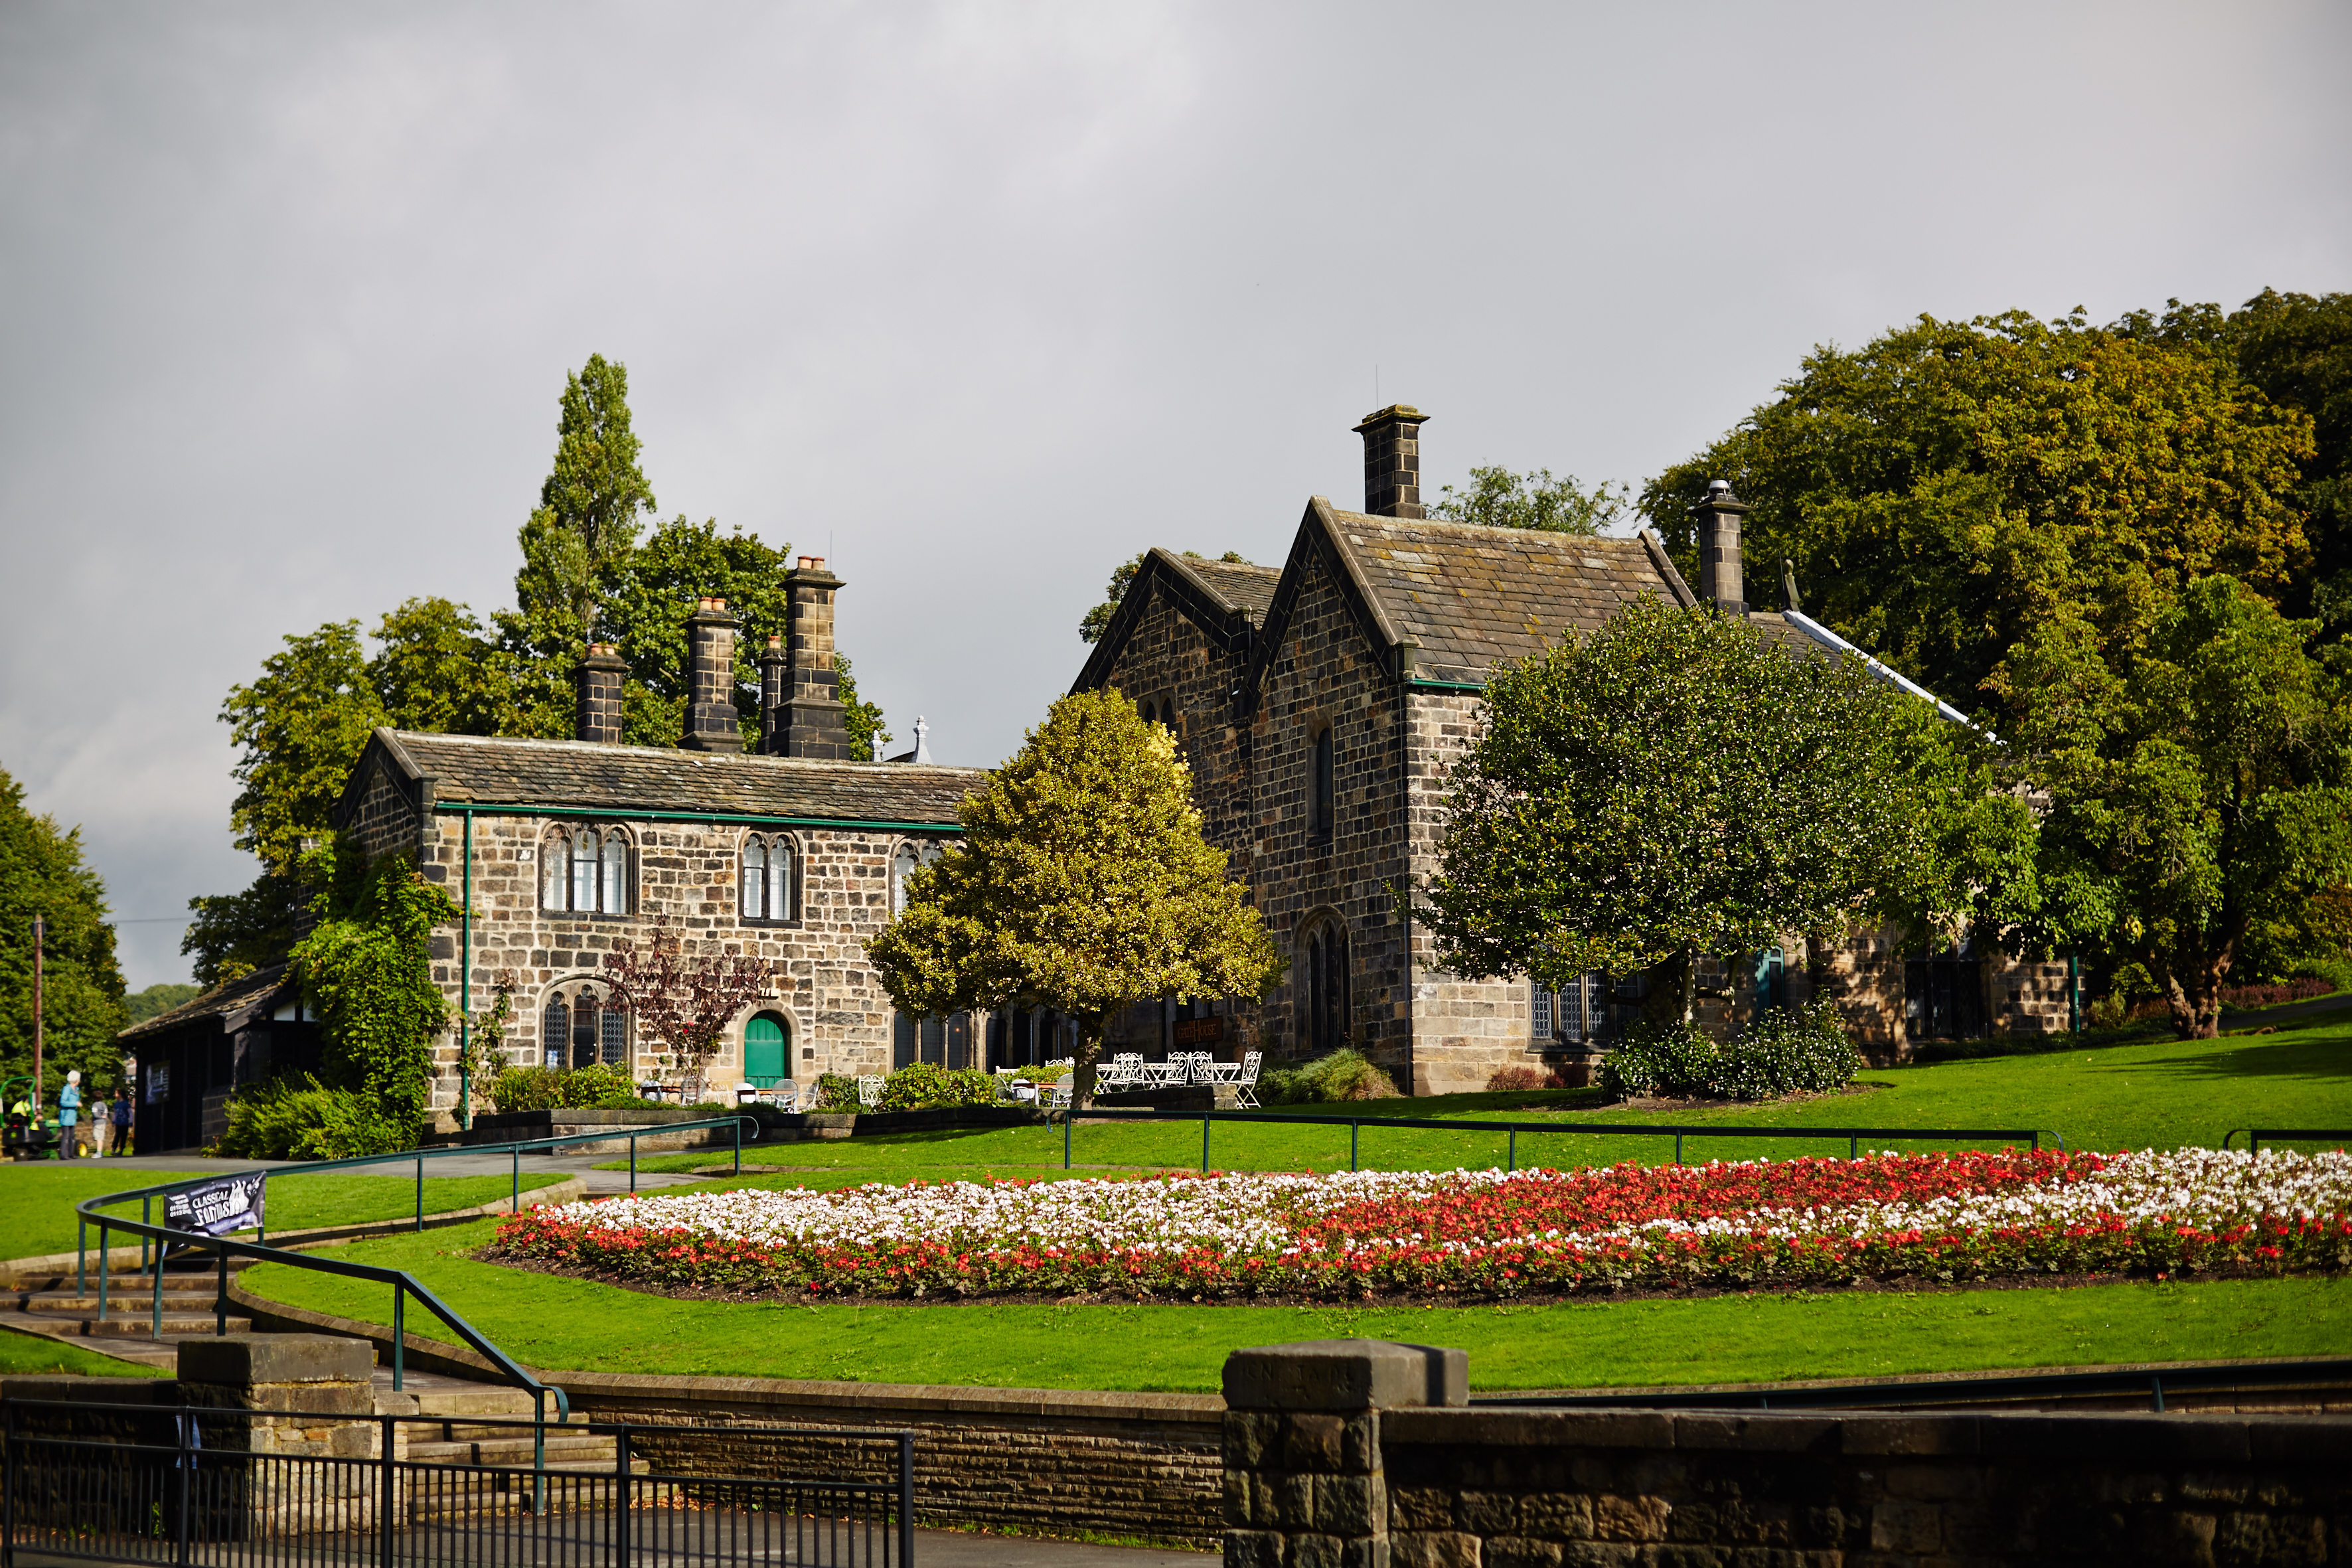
[424,813,941,1107]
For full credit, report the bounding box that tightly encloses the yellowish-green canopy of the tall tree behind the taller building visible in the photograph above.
[1642,308,2314,705]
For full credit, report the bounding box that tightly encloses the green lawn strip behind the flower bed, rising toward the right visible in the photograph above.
[611,1013,2352,1185]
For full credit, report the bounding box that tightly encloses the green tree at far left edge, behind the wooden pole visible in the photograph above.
[0,769,125,1098]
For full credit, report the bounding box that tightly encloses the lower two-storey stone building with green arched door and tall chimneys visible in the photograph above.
[334,557,986,1109]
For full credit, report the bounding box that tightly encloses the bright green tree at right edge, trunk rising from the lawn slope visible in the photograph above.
[1994,576,2352,1037]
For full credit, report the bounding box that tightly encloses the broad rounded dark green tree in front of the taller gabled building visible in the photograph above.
[1416,599,1971,1018]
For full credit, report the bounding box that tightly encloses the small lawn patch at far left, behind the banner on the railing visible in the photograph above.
[0,1159,564,1258]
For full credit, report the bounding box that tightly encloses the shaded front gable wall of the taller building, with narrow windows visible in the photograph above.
[1249,552,1411,1086]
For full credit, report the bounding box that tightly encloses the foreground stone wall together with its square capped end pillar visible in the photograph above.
[1225,1340,2352,1568]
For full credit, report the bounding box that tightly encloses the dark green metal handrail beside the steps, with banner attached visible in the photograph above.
[73,1117,759,1452]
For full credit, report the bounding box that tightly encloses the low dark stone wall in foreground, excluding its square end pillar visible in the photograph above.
[1381,1411,2352,1568]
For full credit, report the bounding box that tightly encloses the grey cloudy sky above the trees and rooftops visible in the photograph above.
[0,0,2352,987]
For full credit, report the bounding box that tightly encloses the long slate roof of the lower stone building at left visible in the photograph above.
[353,729,988,825]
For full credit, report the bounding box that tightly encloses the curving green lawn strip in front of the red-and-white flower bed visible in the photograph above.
[244,1222,2352,1391]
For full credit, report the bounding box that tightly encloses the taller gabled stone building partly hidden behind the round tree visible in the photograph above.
[1073,404,2065,1093]
